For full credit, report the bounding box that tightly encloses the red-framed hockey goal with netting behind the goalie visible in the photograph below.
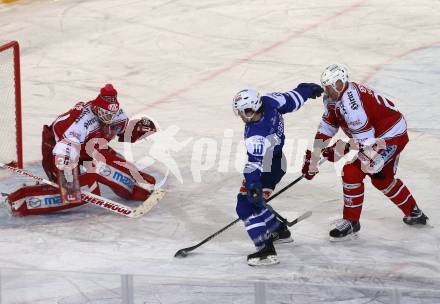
[0,41,23,168]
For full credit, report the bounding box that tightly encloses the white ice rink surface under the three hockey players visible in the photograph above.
[0,0,440,304]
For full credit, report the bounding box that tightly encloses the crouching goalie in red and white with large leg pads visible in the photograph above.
[7,84,156,216]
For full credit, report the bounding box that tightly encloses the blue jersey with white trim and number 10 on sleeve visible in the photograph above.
[243,90,306,182]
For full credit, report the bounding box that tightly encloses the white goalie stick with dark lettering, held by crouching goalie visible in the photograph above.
[0,163,165,218]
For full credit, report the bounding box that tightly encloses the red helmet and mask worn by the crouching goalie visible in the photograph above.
[92,84,119,125]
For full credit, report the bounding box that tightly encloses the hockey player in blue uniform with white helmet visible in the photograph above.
[232,83,323,266]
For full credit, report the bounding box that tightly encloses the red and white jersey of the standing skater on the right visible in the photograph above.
[318,82,407,144]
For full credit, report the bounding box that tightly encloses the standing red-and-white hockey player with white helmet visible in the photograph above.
[303,64,428,240]
